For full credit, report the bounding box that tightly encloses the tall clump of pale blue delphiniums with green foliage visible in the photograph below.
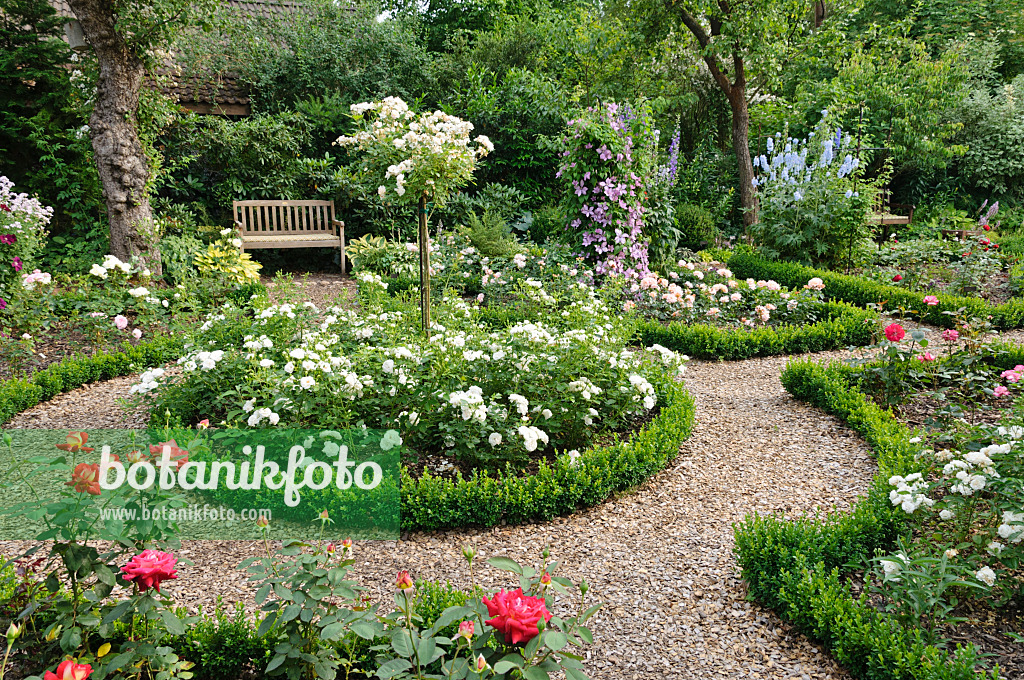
[752,111,879,265]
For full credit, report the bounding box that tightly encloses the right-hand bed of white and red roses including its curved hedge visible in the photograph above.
[736,325,1024,678]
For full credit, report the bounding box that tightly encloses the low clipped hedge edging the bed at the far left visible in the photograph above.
[0,336,181,425]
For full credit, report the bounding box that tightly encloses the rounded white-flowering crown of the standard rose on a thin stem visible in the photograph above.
[335,97,495,205]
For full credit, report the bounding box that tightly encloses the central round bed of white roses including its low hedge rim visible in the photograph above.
[123,274,693,528]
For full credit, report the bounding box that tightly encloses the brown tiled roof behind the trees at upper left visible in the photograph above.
[50,0,302,116]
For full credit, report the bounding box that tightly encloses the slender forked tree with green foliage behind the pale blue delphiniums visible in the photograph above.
[669,0,827,226]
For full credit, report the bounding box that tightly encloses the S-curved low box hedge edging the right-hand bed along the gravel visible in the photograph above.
[733,358,997,680]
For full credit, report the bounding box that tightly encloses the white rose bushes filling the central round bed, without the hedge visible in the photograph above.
[133,284,686,465]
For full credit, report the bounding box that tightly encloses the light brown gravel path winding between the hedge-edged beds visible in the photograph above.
[0,357,874,680]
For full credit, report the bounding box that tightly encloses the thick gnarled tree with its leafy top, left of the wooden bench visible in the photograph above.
[69,0,214,272]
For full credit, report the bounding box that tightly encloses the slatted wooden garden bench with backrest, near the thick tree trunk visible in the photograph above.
[231,201,345,272]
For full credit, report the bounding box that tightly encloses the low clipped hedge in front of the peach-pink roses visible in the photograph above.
[636,302,878,359]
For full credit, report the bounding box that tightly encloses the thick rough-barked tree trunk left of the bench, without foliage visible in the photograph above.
[69,0,161,275]
